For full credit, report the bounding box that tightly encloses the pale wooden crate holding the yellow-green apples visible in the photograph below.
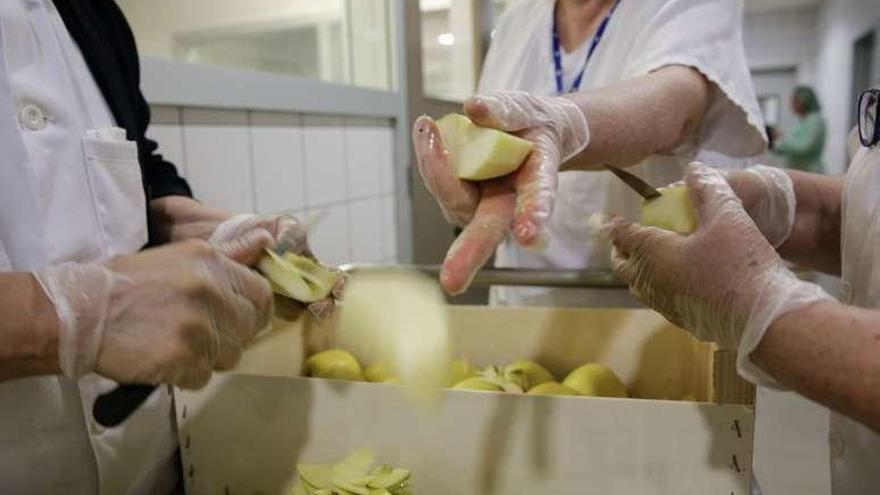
[175,307,754,495]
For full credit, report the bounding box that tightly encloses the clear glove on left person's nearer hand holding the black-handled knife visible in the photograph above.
[35,230,272,388]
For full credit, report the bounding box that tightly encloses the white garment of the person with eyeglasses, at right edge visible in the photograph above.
[829,146,880,495]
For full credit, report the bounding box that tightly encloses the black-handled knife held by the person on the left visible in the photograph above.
[92,210,328,428]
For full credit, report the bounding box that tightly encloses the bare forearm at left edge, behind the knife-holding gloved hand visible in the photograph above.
[0,273,60,381]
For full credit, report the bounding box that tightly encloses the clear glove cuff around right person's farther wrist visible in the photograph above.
[725,165,796,248]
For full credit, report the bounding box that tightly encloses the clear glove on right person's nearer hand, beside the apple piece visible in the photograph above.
[604,165,830,386]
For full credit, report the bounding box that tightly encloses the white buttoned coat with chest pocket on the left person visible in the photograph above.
[0,0,176,494]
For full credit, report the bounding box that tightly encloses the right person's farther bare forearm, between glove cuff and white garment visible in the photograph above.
[779,171,843,274]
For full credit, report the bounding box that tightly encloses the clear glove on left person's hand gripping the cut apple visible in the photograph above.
[208,214,345,318]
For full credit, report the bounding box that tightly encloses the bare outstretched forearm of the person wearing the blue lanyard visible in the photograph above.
[562,66,711,171]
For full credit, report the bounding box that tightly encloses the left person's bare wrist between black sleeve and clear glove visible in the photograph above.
[150,196,231,244]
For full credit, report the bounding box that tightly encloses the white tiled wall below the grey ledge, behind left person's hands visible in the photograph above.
[148,107,397,264]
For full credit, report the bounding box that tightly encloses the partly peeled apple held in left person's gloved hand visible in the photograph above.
[257,249,339,303]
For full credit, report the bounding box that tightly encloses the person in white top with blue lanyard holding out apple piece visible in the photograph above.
[413,0,766,306]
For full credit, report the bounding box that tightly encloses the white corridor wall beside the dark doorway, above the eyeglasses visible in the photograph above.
[816,0,880,173]
